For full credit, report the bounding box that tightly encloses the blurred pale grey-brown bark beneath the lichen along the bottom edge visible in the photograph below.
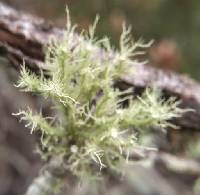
[26,151,200,195]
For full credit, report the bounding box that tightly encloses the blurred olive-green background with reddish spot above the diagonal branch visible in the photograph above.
[1,0,200,79]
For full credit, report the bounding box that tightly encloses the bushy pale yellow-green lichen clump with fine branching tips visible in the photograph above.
[14,10,181,180]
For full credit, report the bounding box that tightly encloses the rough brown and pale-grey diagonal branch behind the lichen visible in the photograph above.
[0,3,200,130]
